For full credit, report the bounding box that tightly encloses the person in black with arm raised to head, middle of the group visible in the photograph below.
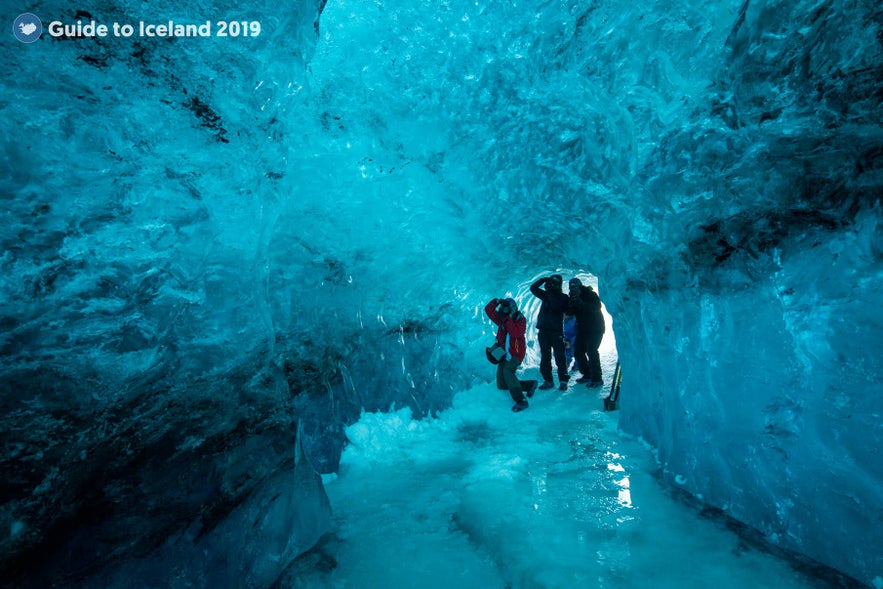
[530,274,570,391]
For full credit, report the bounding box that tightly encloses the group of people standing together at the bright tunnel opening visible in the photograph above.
[484,274,605,411]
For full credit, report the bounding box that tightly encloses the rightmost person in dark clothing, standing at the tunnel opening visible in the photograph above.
[568,278,605,388]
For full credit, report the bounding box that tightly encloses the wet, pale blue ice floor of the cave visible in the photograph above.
[282,366,826,589]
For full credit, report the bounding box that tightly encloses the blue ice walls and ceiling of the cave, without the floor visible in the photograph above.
[0,0,883,587]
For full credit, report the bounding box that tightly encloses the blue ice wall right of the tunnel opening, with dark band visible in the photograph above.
[607,3,883,583]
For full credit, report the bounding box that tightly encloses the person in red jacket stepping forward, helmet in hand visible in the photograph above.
[484,298,537,412]
